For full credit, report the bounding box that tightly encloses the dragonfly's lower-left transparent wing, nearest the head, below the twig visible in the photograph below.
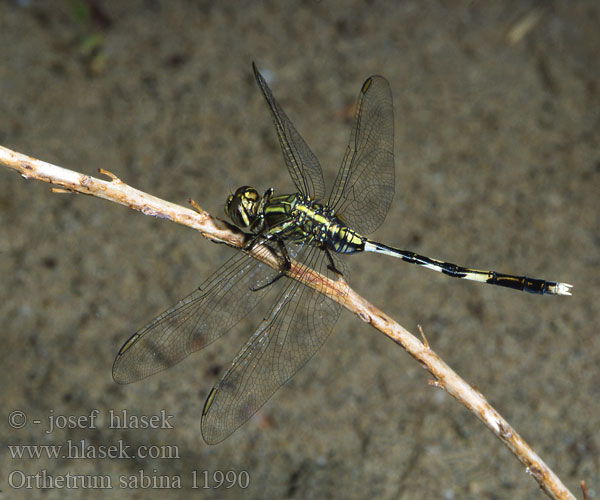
[113,246,284,384]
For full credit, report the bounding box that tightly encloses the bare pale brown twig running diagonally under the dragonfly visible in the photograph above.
[0,146,575,500]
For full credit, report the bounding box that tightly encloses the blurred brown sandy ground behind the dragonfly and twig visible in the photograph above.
[0,0,600,499]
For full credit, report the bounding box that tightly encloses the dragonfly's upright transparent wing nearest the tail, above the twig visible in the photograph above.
[329,76,395,234]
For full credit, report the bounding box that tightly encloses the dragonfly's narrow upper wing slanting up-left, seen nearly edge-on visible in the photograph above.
[252,63,325,200]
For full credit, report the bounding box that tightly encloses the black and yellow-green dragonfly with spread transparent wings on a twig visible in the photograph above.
[113,63,571,444]
